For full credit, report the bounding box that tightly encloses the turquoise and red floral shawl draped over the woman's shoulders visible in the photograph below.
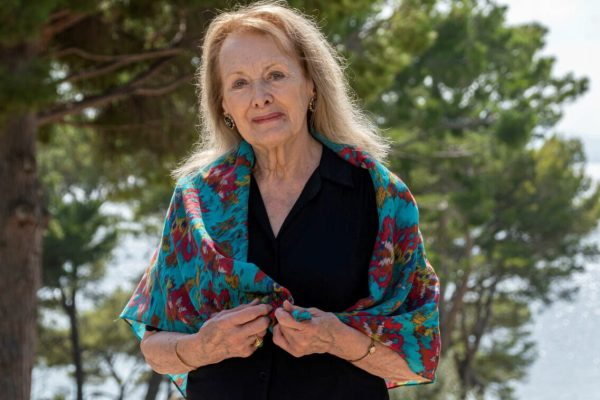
[120,132,440,396]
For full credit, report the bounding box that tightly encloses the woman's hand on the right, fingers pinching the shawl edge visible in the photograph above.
[273,300,341,357]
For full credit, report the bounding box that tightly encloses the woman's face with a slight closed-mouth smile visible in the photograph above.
[219,32,313,148]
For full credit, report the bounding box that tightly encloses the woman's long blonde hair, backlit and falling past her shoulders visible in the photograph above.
[172,1,389,179]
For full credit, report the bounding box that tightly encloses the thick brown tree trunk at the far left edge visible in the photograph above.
[0,113,45,400]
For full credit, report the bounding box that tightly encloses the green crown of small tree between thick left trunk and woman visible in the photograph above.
[38,122,118,291]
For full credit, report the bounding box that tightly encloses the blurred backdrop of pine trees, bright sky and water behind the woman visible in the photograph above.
[0,0,600,400]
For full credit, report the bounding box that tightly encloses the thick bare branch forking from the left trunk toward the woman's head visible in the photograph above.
[37,57,193,127]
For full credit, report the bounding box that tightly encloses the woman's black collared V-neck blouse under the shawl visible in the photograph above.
[175,146,389,400]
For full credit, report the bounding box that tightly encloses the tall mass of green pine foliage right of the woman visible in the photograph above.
[369,1,600,399]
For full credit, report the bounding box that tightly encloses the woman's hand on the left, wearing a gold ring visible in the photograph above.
[195,299,272,363]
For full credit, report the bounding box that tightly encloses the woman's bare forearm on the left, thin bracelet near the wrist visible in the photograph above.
[140,331,216,374]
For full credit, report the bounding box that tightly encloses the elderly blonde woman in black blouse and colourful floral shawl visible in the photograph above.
[121,2,440,400]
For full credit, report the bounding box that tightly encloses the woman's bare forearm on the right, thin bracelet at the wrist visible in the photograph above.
[330,321,425,382]
